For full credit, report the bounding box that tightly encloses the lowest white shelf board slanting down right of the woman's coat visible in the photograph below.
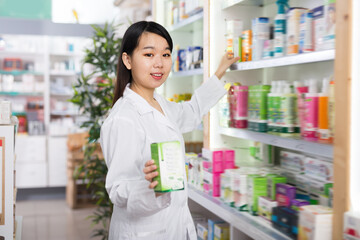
[188,186,291,240]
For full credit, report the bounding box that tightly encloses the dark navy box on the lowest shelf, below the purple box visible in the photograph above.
[271,206,299,239]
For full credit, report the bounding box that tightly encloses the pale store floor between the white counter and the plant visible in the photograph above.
[16,199,100,240]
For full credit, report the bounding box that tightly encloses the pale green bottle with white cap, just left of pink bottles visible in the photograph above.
[281,83,297,136]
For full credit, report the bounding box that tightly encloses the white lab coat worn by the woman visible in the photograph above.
[100,76,226,240]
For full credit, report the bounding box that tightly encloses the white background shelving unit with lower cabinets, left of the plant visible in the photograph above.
[0,35,87,189]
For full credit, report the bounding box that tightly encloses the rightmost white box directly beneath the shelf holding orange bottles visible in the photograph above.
[304,157,333,182]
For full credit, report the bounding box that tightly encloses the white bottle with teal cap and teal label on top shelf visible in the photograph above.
[274,0,289,57]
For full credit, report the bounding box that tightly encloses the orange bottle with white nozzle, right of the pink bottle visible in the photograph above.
[318,78,331,143]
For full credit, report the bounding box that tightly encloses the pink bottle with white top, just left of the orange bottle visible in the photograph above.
[304,79,319,141]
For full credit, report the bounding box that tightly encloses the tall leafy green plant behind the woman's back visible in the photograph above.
[70,23,122,240]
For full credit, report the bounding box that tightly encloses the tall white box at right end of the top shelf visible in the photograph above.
[324,0,336,49]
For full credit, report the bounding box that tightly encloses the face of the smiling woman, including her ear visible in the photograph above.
[123,32,172,89]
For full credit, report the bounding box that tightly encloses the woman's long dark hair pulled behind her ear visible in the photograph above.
[113,21,173,106]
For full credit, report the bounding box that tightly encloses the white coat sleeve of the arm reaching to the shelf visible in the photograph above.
[169,75,227,133]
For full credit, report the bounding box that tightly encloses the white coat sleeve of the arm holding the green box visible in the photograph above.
[100,118,171,216]
